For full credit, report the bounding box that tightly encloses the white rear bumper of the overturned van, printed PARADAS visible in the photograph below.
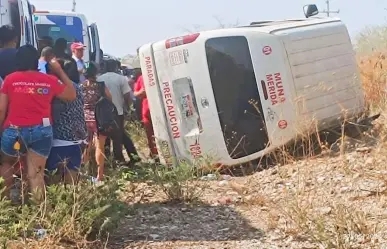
[139,44,176,165]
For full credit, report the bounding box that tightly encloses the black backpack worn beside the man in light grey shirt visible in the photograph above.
[94,82,119,136]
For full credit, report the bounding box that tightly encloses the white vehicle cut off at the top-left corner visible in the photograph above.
[0,0,38,48]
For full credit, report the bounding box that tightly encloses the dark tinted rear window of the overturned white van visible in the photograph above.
[205,36,268,159]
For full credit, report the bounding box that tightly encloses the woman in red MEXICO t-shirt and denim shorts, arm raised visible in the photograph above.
[0,45,76,200]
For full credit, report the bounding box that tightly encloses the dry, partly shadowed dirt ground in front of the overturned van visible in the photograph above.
[107,136,387,249]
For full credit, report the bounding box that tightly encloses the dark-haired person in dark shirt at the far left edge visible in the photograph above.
[0,25,19,80]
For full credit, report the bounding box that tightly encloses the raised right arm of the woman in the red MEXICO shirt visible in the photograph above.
[50,60,77,101]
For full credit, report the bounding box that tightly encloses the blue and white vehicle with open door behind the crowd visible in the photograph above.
[34,10,103,64]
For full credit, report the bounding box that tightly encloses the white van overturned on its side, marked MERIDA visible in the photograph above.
[139,5,376,165]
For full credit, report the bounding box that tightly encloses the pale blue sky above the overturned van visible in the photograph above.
[30,0,387,56]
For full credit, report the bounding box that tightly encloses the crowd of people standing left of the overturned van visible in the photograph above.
[0,25,157,200]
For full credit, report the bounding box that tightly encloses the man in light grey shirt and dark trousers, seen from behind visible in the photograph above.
[97,60,139,163]
